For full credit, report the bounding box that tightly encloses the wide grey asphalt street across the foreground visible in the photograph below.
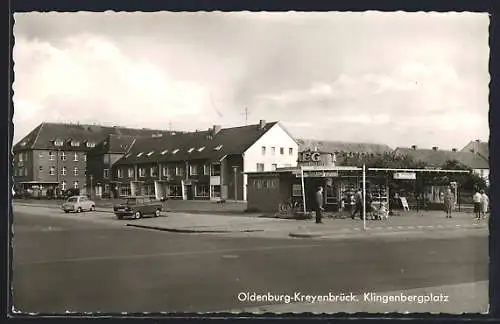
[12,213,488,313]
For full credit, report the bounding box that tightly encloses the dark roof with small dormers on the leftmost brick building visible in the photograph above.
[13,122,176,151]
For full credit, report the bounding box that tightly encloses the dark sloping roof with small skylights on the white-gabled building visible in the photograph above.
[116,122,278,165]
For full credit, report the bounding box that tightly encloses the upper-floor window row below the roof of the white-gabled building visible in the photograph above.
[117,164,220,178]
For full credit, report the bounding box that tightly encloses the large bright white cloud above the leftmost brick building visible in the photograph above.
[13,34,210,142]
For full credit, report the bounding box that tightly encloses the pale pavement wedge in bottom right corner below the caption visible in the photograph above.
[229,281,489,314]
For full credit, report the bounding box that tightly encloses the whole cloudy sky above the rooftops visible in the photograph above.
[13,12,490,149]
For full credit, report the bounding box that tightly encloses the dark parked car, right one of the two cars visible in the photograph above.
[113,197,163,219]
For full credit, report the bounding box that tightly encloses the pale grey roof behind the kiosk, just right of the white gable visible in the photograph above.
[297,139,392,154]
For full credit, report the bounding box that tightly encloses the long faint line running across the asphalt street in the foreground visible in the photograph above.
[16,244,322,265]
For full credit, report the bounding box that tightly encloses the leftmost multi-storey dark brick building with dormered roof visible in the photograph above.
[11,122,174,196]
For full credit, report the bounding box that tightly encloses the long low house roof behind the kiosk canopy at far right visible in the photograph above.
[394,147,489,169]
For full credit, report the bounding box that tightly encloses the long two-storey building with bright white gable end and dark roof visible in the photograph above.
[113,120,298,200]
